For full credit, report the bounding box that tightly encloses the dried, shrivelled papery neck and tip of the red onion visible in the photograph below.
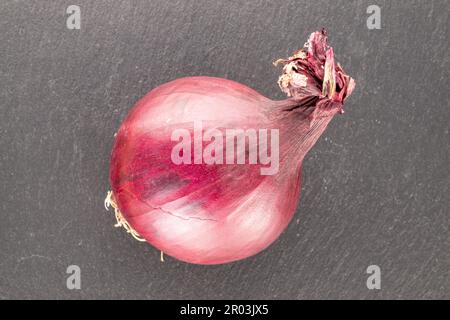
[268,29,355,168]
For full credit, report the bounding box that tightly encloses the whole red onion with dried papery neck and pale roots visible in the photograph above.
[106,30,355,264]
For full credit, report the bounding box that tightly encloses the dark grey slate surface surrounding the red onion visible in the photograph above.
[0,0,450,299]
